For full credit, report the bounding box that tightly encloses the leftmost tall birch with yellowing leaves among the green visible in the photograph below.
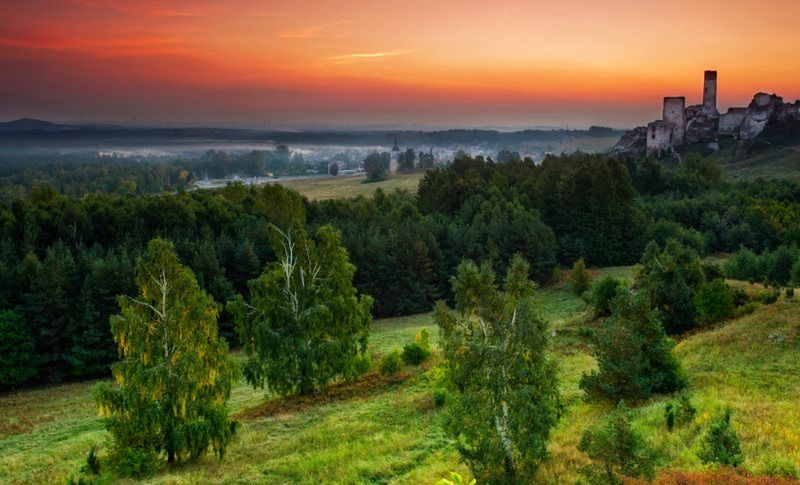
[94,239,238,466]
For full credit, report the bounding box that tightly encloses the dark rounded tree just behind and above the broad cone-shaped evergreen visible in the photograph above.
[635,239,705,334]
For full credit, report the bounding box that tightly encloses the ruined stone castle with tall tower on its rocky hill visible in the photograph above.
[610,71,800,157]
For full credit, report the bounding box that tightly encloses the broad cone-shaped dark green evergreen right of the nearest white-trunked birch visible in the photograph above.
[580,291,686,402]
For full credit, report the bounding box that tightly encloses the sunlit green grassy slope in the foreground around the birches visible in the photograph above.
[0,268,800,483]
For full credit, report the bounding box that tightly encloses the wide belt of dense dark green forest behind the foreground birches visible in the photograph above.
[0,154,800,385]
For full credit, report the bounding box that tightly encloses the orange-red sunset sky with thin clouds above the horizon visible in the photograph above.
[0,0,800,127]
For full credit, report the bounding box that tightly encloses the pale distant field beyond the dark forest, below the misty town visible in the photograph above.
[280,172,424,200]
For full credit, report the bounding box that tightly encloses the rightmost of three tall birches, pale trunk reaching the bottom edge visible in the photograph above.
[434,256,561,480]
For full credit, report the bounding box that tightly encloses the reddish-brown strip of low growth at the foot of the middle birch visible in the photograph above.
[234,359,432,419]
